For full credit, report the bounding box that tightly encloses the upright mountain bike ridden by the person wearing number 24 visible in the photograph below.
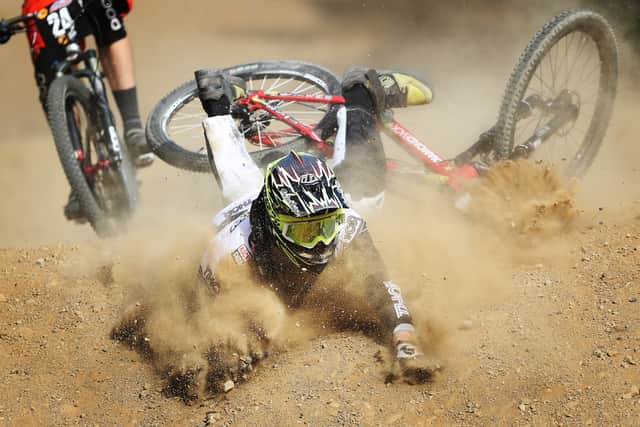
[0,12,138,236]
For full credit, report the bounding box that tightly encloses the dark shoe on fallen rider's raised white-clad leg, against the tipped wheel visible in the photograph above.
[194,68,245,117]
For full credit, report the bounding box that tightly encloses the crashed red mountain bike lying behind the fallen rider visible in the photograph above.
[147,10,618,189]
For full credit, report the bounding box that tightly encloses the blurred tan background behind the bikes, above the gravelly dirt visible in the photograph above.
[0,0,640,246]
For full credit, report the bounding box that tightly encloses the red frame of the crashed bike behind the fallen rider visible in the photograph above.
[238,90,478,190]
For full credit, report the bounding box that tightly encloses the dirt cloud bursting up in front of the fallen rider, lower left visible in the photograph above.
[112,251,286,401]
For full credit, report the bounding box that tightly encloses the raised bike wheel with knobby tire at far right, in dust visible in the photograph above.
[494,10,618,176]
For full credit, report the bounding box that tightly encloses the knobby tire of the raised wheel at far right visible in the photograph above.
[494,10,618,176]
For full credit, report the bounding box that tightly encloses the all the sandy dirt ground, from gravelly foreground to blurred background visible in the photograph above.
[0,0,640,426]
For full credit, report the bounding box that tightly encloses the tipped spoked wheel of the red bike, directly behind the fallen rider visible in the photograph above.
[147,61,341,172]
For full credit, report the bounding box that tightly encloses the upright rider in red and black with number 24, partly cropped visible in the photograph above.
[17,0,153,221]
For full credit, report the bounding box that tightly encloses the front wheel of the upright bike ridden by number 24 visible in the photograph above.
[47,76,137,237]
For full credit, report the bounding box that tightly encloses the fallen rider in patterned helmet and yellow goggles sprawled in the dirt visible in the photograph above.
[196,70,439,383]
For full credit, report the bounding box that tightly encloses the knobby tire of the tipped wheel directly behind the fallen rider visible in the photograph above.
[146,61,341,173]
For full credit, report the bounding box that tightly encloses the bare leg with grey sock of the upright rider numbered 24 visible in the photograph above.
[86,0,153,166]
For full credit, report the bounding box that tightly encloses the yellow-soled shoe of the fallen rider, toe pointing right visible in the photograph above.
[378,72,433,108]
